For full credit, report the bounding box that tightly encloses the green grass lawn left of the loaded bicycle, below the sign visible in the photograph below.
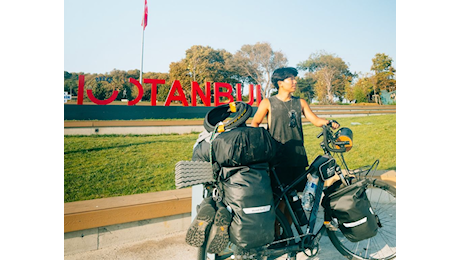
[64,134,198,202]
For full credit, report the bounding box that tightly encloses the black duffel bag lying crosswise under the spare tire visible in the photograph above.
[192,126,278,167]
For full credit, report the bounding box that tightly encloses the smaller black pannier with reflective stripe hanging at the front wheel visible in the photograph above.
[322,180,378,242]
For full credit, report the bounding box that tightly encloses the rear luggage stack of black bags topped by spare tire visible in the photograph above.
[186,102,278,249]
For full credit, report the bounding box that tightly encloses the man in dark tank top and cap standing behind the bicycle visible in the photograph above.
[251,67,340,235]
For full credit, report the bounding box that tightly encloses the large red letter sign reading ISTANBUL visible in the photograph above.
[77,75,262,107]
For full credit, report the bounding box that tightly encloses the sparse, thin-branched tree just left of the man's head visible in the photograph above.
[234,42,288,98]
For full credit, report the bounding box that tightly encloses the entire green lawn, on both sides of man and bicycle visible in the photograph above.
[64,115,396,202]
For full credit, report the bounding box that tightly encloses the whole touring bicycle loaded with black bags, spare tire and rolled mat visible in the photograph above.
[175,102,396,260]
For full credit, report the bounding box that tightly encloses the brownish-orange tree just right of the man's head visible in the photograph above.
[297,51,355,103]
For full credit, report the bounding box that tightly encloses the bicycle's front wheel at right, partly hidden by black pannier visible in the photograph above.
[325,178,396,260]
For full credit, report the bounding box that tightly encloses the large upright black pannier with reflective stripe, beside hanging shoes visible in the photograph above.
[218,163,276,249]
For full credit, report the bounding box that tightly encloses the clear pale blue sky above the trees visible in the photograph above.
[64,0,396,76]
